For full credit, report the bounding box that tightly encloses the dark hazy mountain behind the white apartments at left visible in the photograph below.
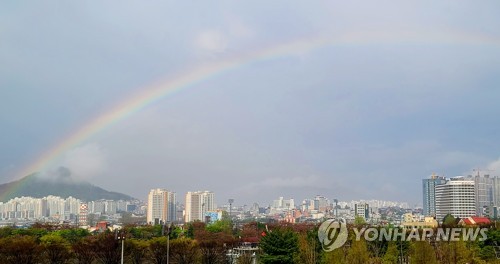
[0,167,134,202]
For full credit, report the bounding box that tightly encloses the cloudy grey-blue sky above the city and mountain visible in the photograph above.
[0,1,500,205]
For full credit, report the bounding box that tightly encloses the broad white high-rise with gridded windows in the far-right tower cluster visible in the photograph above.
[435,177,476,221]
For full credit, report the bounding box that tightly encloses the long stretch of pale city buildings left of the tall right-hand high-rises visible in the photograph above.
[0,188,414,226]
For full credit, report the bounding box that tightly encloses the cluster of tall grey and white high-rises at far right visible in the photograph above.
[422,173,500,221]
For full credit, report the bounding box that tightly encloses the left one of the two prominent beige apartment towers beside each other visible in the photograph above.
[146,189,176,224]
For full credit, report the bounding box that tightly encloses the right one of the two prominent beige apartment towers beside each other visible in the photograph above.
[184,191,216,223]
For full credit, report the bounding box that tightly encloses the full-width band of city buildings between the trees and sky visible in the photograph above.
[0,171,500,227]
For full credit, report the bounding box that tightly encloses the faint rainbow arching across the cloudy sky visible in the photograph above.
[0,31,500,200]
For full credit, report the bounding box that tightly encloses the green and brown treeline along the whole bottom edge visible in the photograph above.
[0,220,500,264]
